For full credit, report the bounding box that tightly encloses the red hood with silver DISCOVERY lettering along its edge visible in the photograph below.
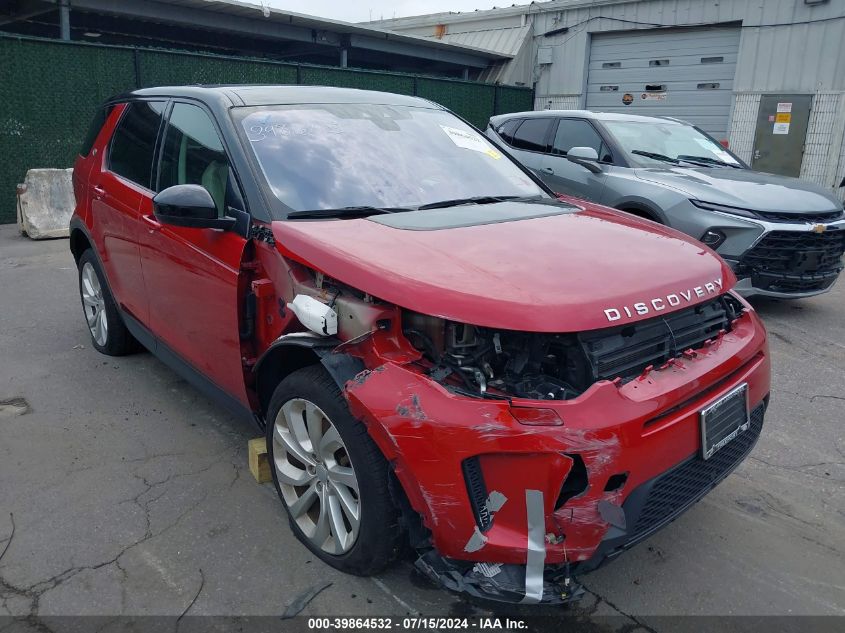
[273,205,736,332]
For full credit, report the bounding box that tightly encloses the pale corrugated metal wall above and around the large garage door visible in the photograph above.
[528,0,845,95]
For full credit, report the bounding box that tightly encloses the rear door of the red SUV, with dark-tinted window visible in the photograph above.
[90,101,167,323]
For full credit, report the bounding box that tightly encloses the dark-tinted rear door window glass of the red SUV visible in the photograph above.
[109,101,165,189]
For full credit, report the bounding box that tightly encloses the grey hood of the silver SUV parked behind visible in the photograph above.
[635,166,842,213]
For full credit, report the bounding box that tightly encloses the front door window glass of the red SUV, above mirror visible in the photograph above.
[158,103,235,218]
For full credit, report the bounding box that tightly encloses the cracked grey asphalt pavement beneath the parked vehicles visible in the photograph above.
[0,226,845,630]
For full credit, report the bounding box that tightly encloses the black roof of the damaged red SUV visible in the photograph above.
[129,84,442,109]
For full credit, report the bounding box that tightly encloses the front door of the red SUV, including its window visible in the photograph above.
[141,101,248,404]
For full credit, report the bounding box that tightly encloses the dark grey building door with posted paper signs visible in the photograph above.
[751,95,813,178]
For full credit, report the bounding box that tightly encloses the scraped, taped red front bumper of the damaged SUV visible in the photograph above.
[346,311,769,604]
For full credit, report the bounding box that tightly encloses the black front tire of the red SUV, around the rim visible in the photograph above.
[267,365,403,576]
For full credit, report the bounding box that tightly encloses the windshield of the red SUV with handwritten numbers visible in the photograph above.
[236,104,548,210]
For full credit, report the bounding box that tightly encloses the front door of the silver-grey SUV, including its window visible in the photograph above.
[540,118,613,202]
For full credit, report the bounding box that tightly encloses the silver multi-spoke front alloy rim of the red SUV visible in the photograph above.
[273,398,361,556]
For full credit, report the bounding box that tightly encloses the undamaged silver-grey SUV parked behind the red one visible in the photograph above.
[486,110,845,298]
